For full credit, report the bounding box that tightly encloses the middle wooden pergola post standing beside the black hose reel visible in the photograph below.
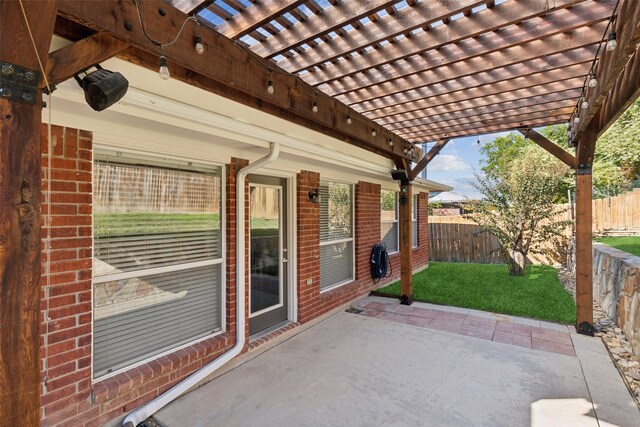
[399,179,413,305]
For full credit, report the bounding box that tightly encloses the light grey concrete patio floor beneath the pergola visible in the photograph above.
[155,298,640,427]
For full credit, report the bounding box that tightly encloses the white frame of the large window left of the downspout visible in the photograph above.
[91,149,227,384]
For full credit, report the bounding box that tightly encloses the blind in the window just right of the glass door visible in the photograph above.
[318,181,354,290]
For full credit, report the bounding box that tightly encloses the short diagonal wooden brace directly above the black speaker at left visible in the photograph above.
[41,33,129,90]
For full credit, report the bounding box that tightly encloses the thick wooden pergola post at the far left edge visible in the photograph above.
[0,0,57,426]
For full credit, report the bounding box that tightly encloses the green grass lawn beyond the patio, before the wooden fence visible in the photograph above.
[378,262,576,324]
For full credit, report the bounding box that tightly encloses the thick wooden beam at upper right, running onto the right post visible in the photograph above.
[572,1,640,143]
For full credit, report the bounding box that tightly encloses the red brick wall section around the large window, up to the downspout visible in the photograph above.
[41,126,238,426]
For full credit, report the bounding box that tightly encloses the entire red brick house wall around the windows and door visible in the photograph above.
[41,126,428,426]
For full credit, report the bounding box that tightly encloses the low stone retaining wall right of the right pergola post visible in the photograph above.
[593,243,640,356]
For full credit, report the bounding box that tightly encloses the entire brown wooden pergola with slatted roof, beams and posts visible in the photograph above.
[0,0,640,425]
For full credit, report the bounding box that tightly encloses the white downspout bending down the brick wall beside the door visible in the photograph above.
[122,142,280,427]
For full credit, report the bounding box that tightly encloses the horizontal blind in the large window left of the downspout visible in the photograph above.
[93,151,223,377]
